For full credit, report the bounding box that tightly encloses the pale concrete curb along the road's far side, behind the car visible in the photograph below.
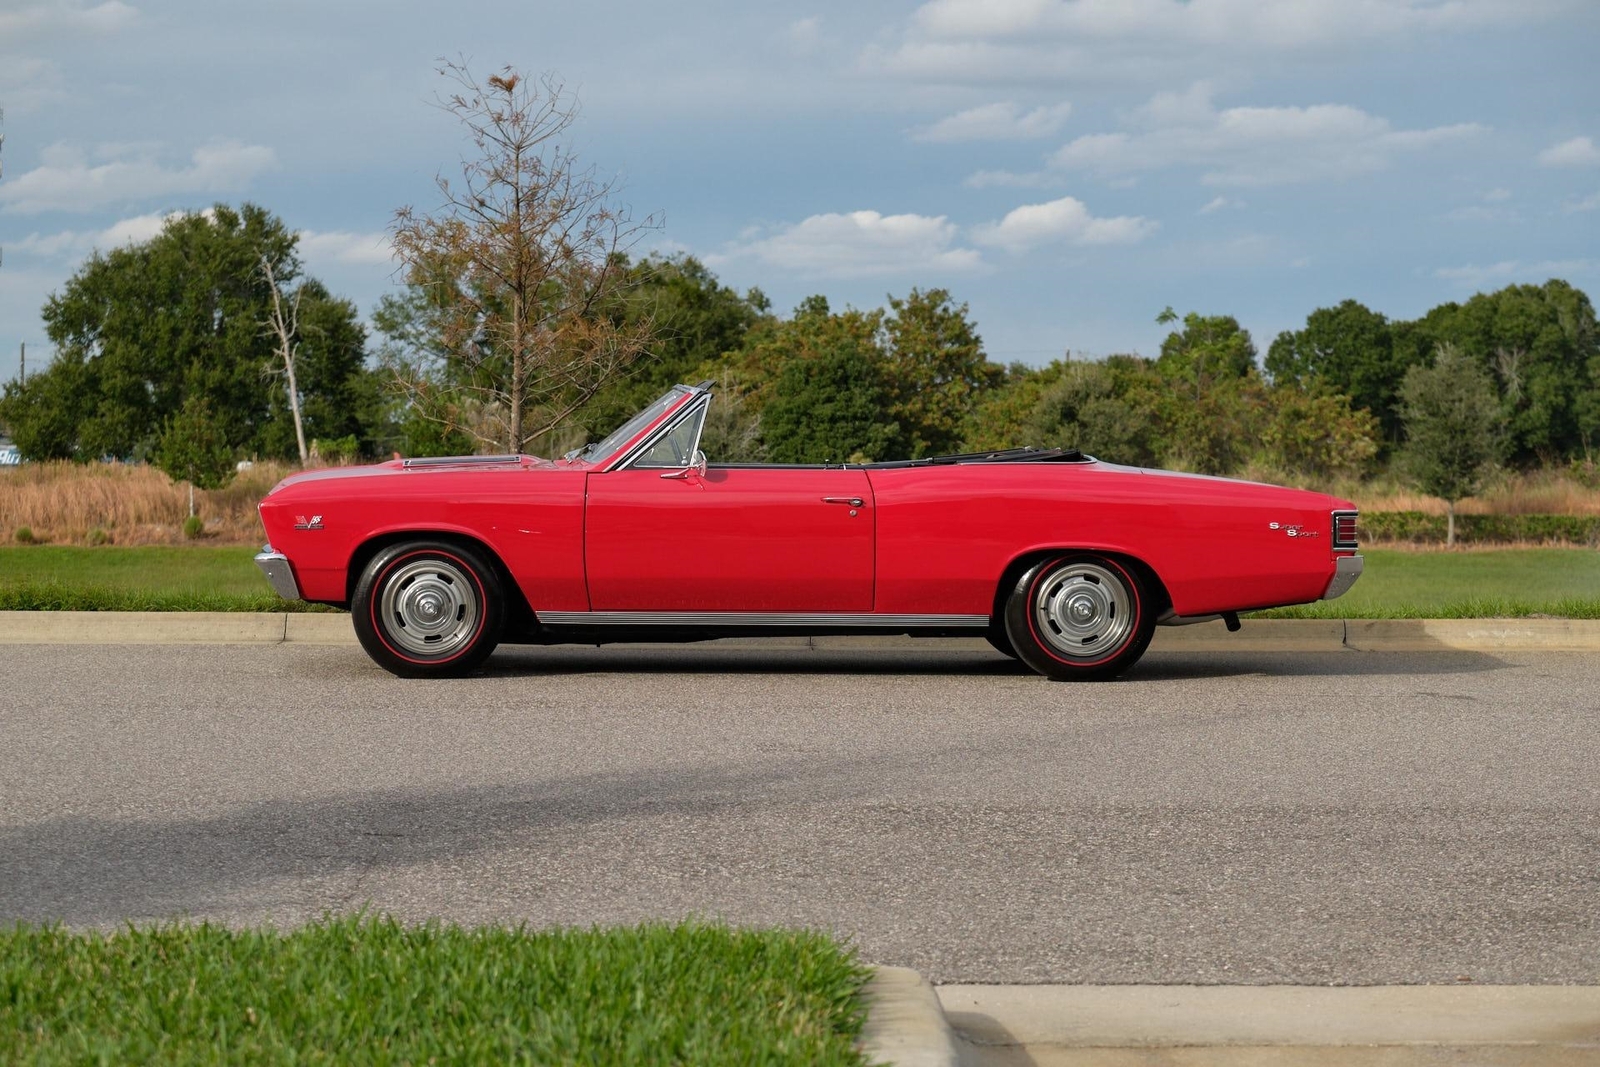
[0,611,1600,653]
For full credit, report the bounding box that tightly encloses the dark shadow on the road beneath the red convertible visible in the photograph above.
[480,643,1510,685]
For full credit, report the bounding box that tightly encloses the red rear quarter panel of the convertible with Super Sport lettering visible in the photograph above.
[869,462,1342,614]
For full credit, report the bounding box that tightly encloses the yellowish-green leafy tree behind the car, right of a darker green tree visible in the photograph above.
[882,290,1005,459]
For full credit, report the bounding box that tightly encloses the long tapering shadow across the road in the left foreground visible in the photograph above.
[0,753,902,928]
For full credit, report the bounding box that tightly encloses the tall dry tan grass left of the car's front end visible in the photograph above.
[0,462,293,544]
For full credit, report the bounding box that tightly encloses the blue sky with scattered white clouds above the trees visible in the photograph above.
[0,0,1600,381]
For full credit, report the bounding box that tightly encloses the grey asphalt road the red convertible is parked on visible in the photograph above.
[0,643,1600,984]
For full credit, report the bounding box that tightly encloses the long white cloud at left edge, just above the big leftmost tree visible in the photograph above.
[0,141,277,214]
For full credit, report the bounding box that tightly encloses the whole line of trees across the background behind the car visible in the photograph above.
[0,64,1600,534]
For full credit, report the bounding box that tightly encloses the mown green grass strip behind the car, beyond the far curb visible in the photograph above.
[0,545,1600,619]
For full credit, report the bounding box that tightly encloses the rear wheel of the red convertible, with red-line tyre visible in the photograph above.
[1005,555,1155,681]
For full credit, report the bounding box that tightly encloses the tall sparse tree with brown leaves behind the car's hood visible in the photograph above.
[394,61,654,451]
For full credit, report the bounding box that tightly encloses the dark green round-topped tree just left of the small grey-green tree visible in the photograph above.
[1266,301,1416,440]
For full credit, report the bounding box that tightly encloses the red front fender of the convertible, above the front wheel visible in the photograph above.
[261,467,589,611]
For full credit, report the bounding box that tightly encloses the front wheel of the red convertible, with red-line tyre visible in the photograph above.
[350,541,506,678]
